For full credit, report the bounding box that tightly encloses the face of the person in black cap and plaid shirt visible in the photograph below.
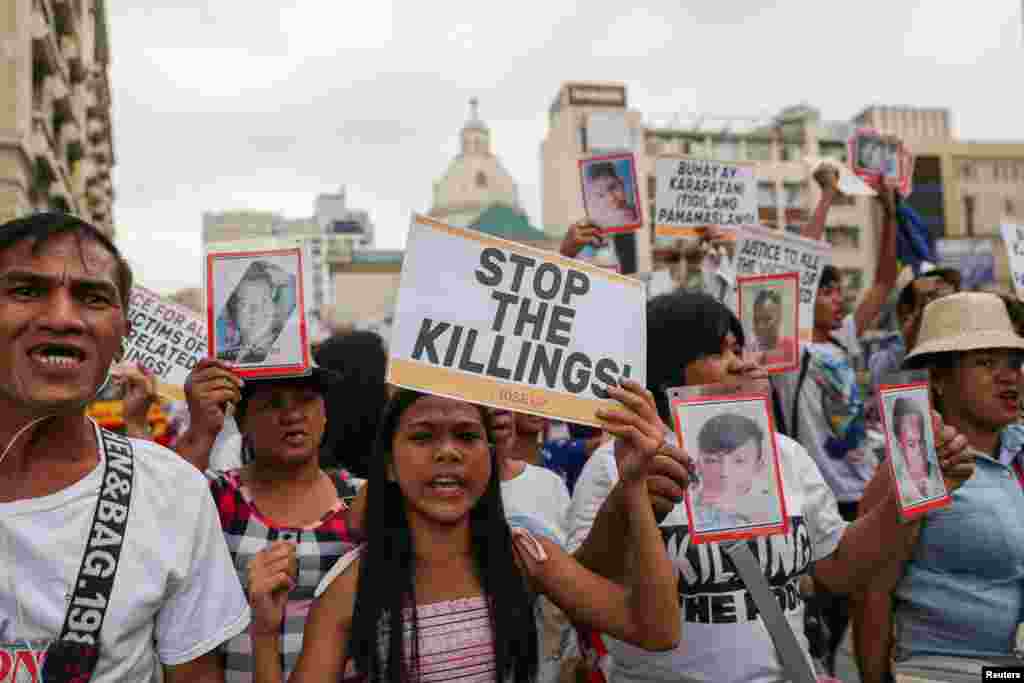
[241,382,327,467]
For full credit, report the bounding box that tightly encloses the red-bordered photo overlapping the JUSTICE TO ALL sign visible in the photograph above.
[736,272,800,375]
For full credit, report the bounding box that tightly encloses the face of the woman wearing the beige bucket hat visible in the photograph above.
[936,349,1022,431]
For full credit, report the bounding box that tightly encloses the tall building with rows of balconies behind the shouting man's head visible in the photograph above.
[0,0,115,237]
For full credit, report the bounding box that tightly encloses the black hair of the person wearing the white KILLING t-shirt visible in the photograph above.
[647,290,743,425]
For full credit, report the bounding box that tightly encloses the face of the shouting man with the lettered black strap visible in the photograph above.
[0,232,127,416]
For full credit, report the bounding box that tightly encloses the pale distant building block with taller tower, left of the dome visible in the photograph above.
[203,187,375,338]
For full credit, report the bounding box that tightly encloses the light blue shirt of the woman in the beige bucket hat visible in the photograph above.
[893,425,1024,660]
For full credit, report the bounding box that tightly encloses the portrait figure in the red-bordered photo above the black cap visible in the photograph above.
[217,261,296,365]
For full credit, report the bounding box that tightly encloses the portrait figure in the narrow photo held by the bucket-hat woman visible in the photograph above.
[890,396,945,505]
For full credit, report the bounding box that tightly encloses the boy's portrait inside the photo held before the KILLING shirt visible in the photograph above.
[694,413,781,531]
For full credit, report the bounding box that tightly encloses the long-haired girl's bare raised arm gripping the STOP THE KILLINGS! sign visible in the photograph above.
[516,382,687,650]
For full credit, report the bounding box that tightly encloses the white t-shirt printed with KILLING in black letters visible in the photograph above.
[568,434,847,683]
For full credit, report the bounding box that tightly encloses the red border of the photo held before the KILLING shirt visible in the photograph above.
[670,390,790,544]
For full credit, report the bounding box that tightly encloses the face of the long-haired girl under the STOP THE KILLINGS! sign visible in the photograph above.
[389,396,492,524]
